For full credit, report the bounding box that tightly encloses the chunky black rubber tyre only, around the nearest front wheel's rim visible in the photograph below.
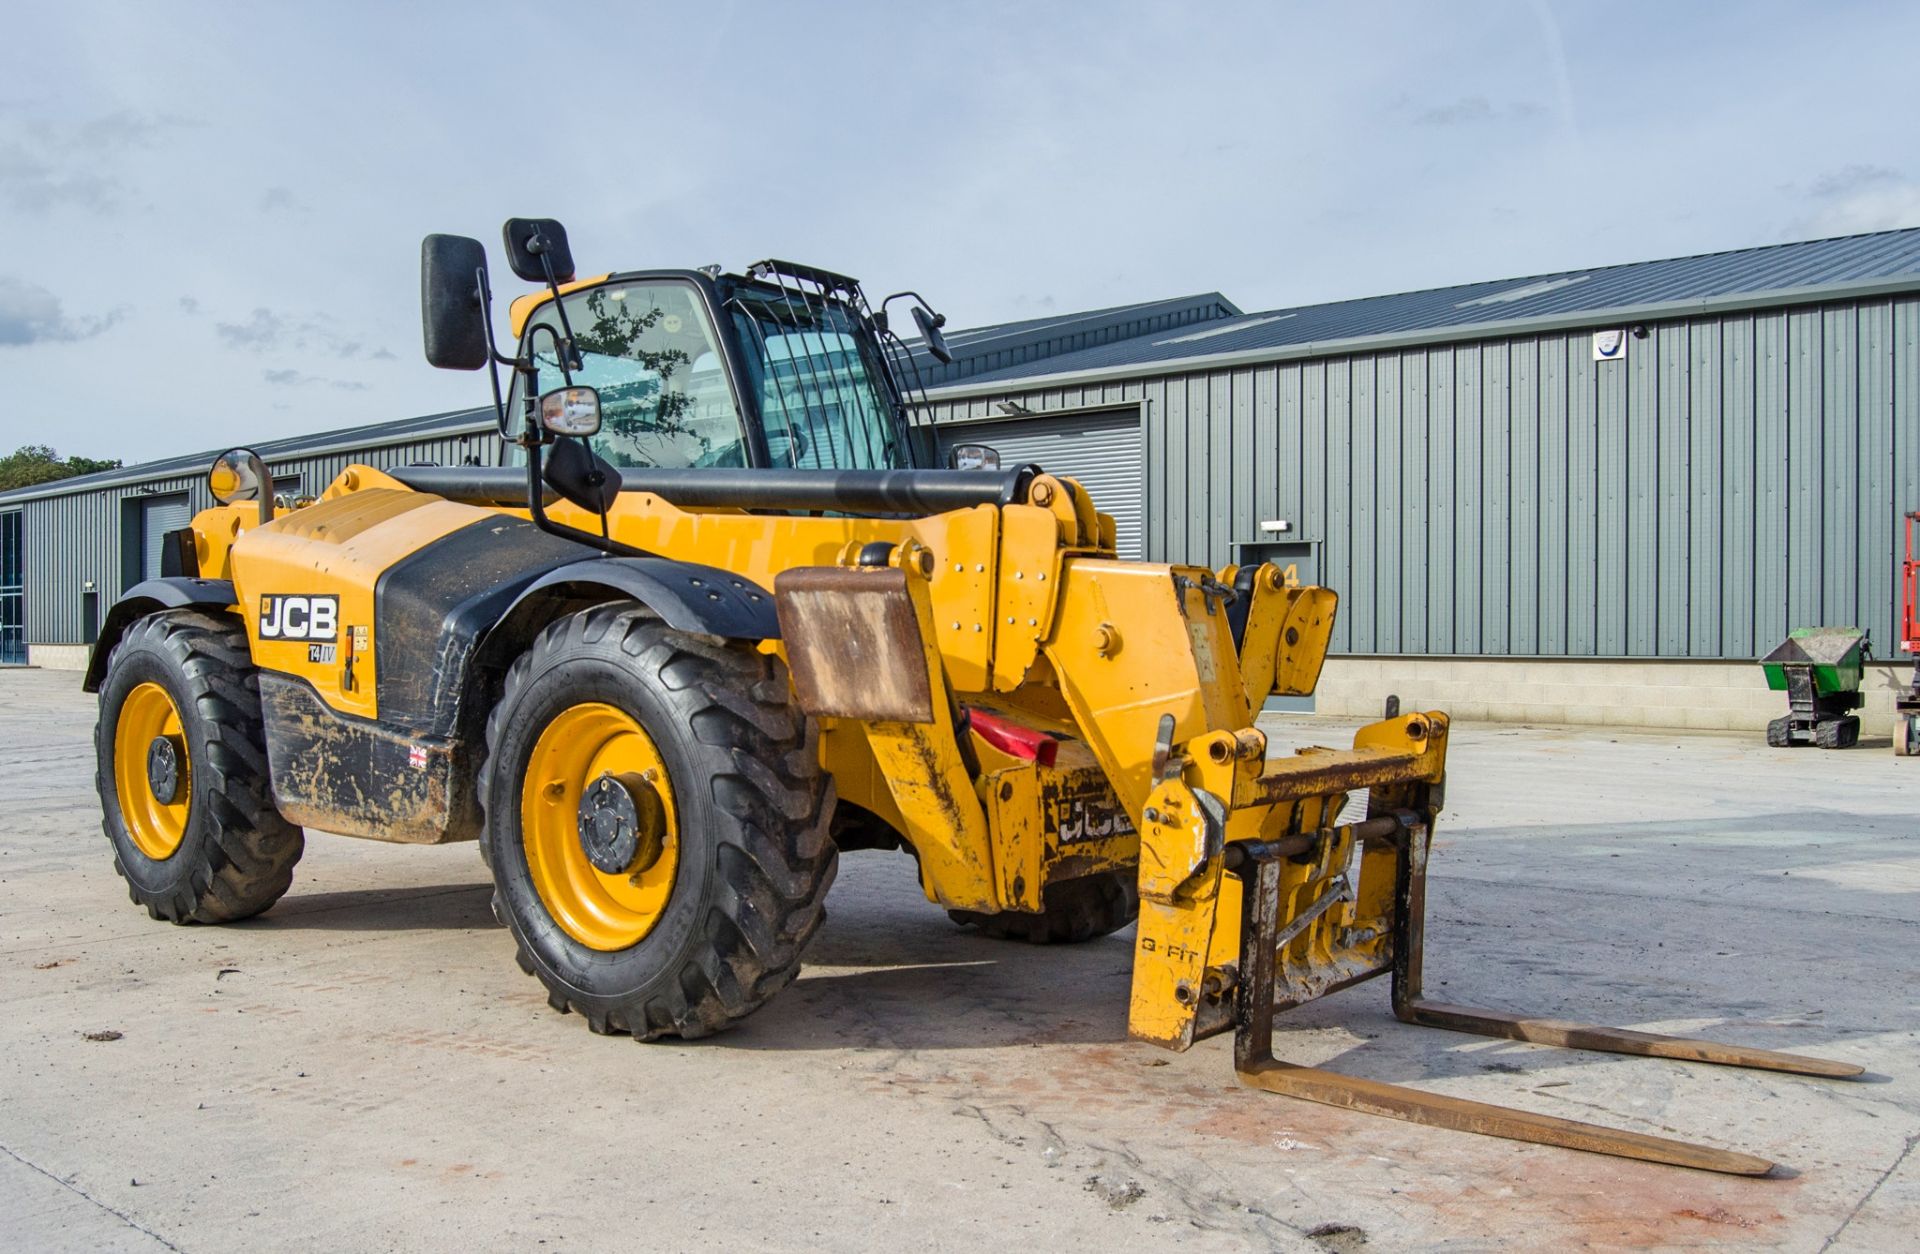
[480,601,837,1041]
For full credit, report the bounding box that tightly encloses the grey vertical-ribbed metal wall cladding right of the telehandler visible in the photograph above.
[929,293,1920,659]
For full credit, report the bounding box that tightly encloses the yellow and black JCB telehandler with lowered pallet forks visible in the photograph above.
[86,219,1859,1173]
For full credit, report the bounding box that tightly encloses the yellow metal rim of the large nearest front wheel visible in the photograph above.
[520,701,680,953]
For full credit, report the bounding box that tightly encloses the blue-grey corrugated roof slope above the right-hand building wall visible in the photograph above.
[945,229,1920,388]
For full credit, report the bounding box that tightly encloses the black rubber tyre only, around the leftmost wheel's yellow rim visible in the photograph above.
[94,609,305,924]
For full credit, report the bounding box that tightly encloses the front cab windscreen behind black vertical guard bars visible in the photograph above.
[728,288,908,470]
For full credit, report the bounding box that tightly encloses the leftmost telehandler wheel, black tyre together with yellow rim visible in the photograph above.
[94,609,305,924]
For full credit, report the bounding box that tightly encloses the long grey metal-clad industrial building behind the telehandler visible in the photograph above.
[0,230,1920,734]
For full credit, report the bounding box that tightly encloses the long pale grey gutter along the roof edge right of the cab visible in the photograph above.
[927,275,1920,401]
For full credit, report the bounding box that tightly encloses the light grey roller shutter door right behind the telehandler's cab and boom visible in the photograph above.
[939,405,1146,559]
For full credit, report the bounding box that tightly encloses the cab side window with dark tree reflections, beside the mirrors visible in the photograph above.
[526,282,747,469]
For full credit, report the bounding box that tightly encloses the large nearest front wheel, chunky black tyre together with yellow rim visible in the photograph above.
[480,601,837,1039]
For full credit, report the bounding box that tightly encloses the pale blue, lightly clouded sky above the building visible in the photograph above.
[0,0,1920,463]
